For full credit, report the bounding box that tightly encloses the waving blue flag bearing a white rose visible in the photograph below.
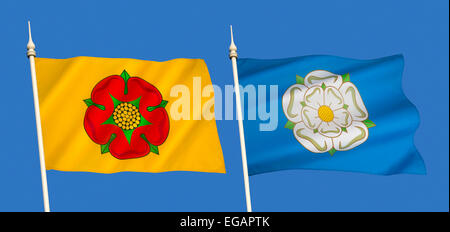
[238,55,426,175]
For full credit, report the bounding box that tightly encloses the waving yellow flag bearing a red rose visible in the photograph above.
[36,57,225,173]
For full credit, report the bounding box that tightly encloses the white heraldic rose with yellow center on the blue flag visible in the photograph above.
[282,70,374,154]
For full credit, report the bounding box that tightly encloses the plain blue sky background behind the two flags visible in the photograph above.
[0,0,449,211]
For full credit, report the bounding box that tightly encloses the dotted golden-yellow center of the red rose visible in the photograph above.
[113,102,141,130]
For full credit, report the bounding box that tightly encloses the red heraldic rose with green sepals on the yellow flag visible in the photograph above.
[84,70,169,159]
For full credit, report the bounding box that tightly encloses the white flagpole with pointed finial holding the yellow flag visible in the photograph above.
[27,21,50,212]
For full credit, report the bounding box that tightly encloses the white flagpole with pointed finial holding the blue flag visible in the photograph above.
[230,25,252,212]
